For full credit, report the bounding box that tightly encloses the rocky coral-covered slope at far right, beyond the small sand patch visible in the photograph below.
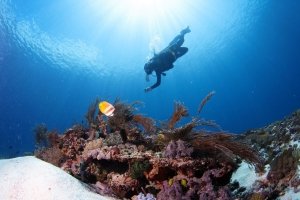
[233,110,300,199]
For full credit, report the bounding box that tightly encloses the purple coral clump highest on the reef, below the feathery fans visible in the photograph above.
[163,140,193,158]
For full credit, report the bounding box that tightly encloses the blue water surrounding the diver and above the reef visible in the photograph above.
[0,0,300,157]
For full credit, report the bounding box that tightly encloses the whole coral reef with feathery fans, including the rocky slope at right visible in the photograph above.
[36,99,300,200]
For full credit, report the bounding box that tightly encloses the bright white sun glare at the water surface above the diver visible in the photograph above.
[89,0,186,29]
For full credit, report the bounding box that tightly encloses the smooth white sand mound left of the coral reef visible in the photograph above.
[0,156,111,200]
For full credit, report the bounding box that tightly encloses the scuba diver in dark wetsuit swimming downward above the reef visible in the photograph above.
[144,26,191,92]
